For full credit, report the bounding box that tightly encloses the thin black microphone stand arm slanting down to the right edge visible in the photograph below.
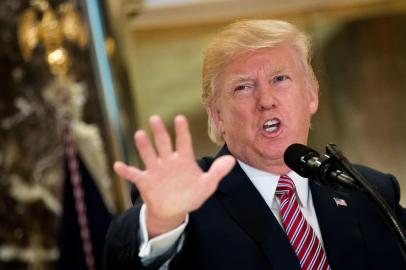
[326,144,406,260]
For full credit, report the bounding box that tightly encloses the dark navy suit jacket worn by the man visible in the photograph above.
[105,147,406,270]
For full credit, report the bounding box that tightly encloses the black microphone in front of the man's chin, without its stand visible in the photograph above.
[283,143,357,188]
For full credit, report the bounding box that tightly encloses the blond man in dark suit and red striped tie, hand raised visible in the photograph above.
[105,20,406,270]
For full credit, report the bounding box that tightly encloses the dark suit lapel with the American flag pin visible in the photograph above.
[309,180,365,269]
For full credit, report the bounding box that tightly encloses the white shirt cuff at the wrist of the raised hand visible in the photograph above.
[138,204,189,261]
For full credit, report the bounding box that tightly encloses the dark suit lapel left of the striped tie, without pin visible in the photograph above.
[216,160,300,270]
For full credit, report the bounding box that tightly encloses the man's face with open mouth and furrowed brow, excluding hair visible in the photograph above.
[210,44,318,174]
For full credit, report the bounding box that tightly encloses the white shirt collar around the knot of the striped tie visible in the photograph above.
[237,160,309,207]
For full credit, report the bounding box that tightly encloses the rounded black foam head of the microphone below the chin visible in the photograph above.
[283,143,320,177]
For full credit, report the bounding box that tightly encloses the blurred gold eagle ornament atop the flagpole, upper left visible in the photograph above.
[18,0,89,76]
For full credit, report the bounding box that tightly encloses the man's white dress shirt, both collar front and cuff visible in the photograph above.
[138,160,323,270]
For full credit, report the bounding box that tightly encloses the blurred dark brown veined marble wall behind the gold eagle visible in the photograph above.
[0,0,114,269]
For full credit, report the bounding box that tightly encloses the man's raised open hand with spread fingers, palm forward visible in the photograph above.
[114,116,235,237]
